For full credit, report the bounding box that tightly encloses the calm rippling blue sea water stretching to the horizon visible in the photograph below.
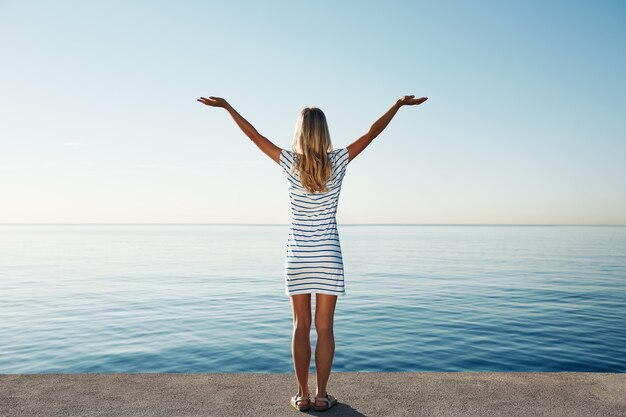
[0,224,626,373]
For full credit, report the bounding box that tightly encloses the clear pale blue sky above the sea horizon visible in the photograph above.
[0,0,626,224]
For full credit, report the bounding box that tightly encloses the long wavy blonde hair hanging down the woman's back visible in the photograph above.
[291,107,333,193]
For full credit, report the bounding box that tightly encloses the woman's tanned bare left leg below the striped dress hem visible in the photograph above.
[291,294,311,398]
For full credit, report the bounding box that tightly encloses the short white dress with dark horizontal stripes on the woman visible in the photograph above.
[280,148,349,296]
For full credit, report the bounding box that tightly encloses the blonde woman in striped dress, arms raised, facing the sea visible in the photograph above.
[198,95,427,411]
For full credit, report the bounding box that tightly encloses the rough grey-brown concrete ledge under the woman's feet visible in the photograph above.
[0,372,626,417]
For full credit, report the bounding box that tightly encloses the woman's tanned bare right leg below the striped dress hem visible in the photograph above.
[315,293,337,406]
